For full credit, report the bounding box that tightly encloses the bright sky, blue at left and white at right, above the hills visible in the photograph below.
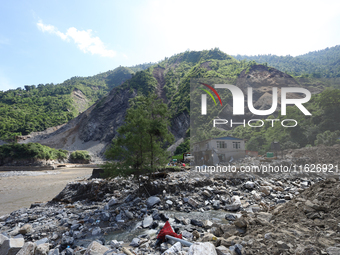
[0,0,340,91]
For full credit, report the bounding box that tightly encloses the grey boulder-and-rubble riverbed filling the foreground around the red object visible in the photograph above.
[0,165,340,255]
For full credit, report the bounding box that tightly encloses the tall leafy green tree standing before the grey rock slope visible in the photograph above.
[103,95,173,183]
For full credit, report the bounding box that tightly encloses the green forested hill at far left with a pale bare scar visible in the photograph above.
[0,63,152,140]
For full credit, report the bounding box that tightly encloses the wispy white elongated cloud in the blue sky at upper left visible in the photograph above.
[37,21,116,58]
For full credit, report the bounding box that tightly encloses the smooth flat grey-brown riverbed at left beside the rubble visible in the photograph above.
[0,168,93,216]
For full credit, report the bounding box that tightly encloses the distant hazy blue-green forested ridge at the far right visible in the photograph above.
[234,45,340,78]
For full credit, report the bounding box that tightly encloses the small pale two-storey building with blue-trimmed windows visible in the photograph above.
[192,136,246,165]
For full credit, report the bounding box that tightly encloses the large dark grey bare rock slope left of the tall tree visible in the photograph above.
[20,88,137,158]
